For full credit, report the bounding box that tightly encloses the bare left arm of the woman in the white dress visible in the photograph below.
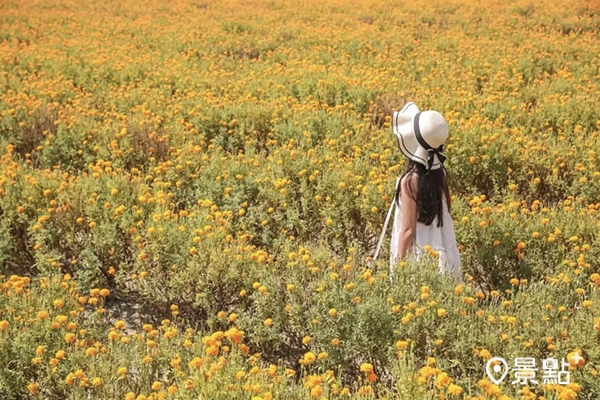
[398,174,417,260]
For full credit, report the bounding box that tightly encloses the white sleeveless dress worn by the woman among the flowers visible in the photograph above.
[390,187,462,282]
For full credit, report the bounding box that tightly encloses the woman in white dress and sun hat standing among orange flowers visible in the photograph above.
[390,103,462,281]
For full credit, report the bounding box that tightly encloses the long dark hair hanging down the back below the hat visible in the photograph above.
[396,160,451,227]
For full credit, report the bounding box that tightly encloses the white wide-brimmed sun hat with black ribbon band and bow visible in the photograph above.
[392,102,448,172]
